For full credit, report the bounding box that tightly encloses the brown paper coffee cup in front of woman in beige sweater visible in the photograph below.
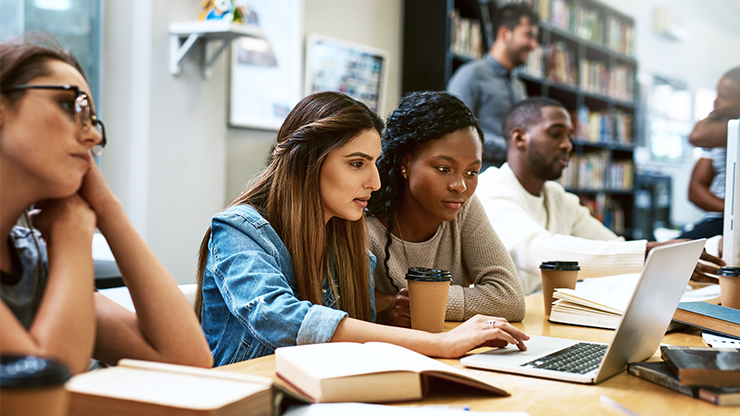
[406,267,452,332]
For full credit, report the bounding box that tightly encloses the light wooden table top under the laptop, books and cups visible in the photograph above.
[216,294,740,416]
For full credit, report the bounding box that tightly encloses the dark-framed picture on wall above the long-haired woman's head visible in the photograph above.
[304,34,389,114]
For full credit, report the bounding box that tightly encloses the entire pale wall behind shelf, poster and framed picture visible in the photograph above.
[102,0,403,283]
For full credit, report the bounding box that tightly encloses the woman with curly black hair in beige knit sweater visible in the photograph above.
[367,91,524,326]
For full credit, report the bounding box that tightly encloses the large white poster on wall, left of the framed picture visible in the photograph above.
[229,0,303,130]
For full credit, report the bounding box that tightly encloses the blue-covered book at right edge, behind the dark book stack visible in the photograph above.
[673,302,740,337]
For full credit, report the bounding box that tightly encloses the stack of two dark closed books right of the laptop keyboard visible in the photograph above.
[627,345,740,406]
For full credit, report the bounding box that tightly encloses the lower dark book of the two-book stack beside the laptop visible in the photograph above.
[627,361,740,406]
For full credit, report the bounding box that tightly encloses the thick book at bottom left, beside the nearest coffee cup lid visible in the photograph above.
[65,360,273,416]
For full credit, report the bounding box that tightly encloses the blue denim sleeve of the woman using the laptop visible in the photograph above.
[210,214,347,349]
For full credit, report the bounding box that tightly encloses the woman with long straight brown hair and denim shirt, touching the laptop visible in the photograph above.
[196,92,528,365]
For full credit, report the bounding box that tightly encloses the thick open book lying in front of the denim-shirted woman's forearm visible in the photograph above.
[275,342,509,403]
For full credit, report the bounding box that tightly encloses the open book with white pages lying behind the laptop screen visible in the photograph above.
[550,273,719,331]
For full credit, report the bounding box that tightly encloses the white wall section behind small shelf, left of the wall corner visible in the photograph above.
[103,0,226,283]
